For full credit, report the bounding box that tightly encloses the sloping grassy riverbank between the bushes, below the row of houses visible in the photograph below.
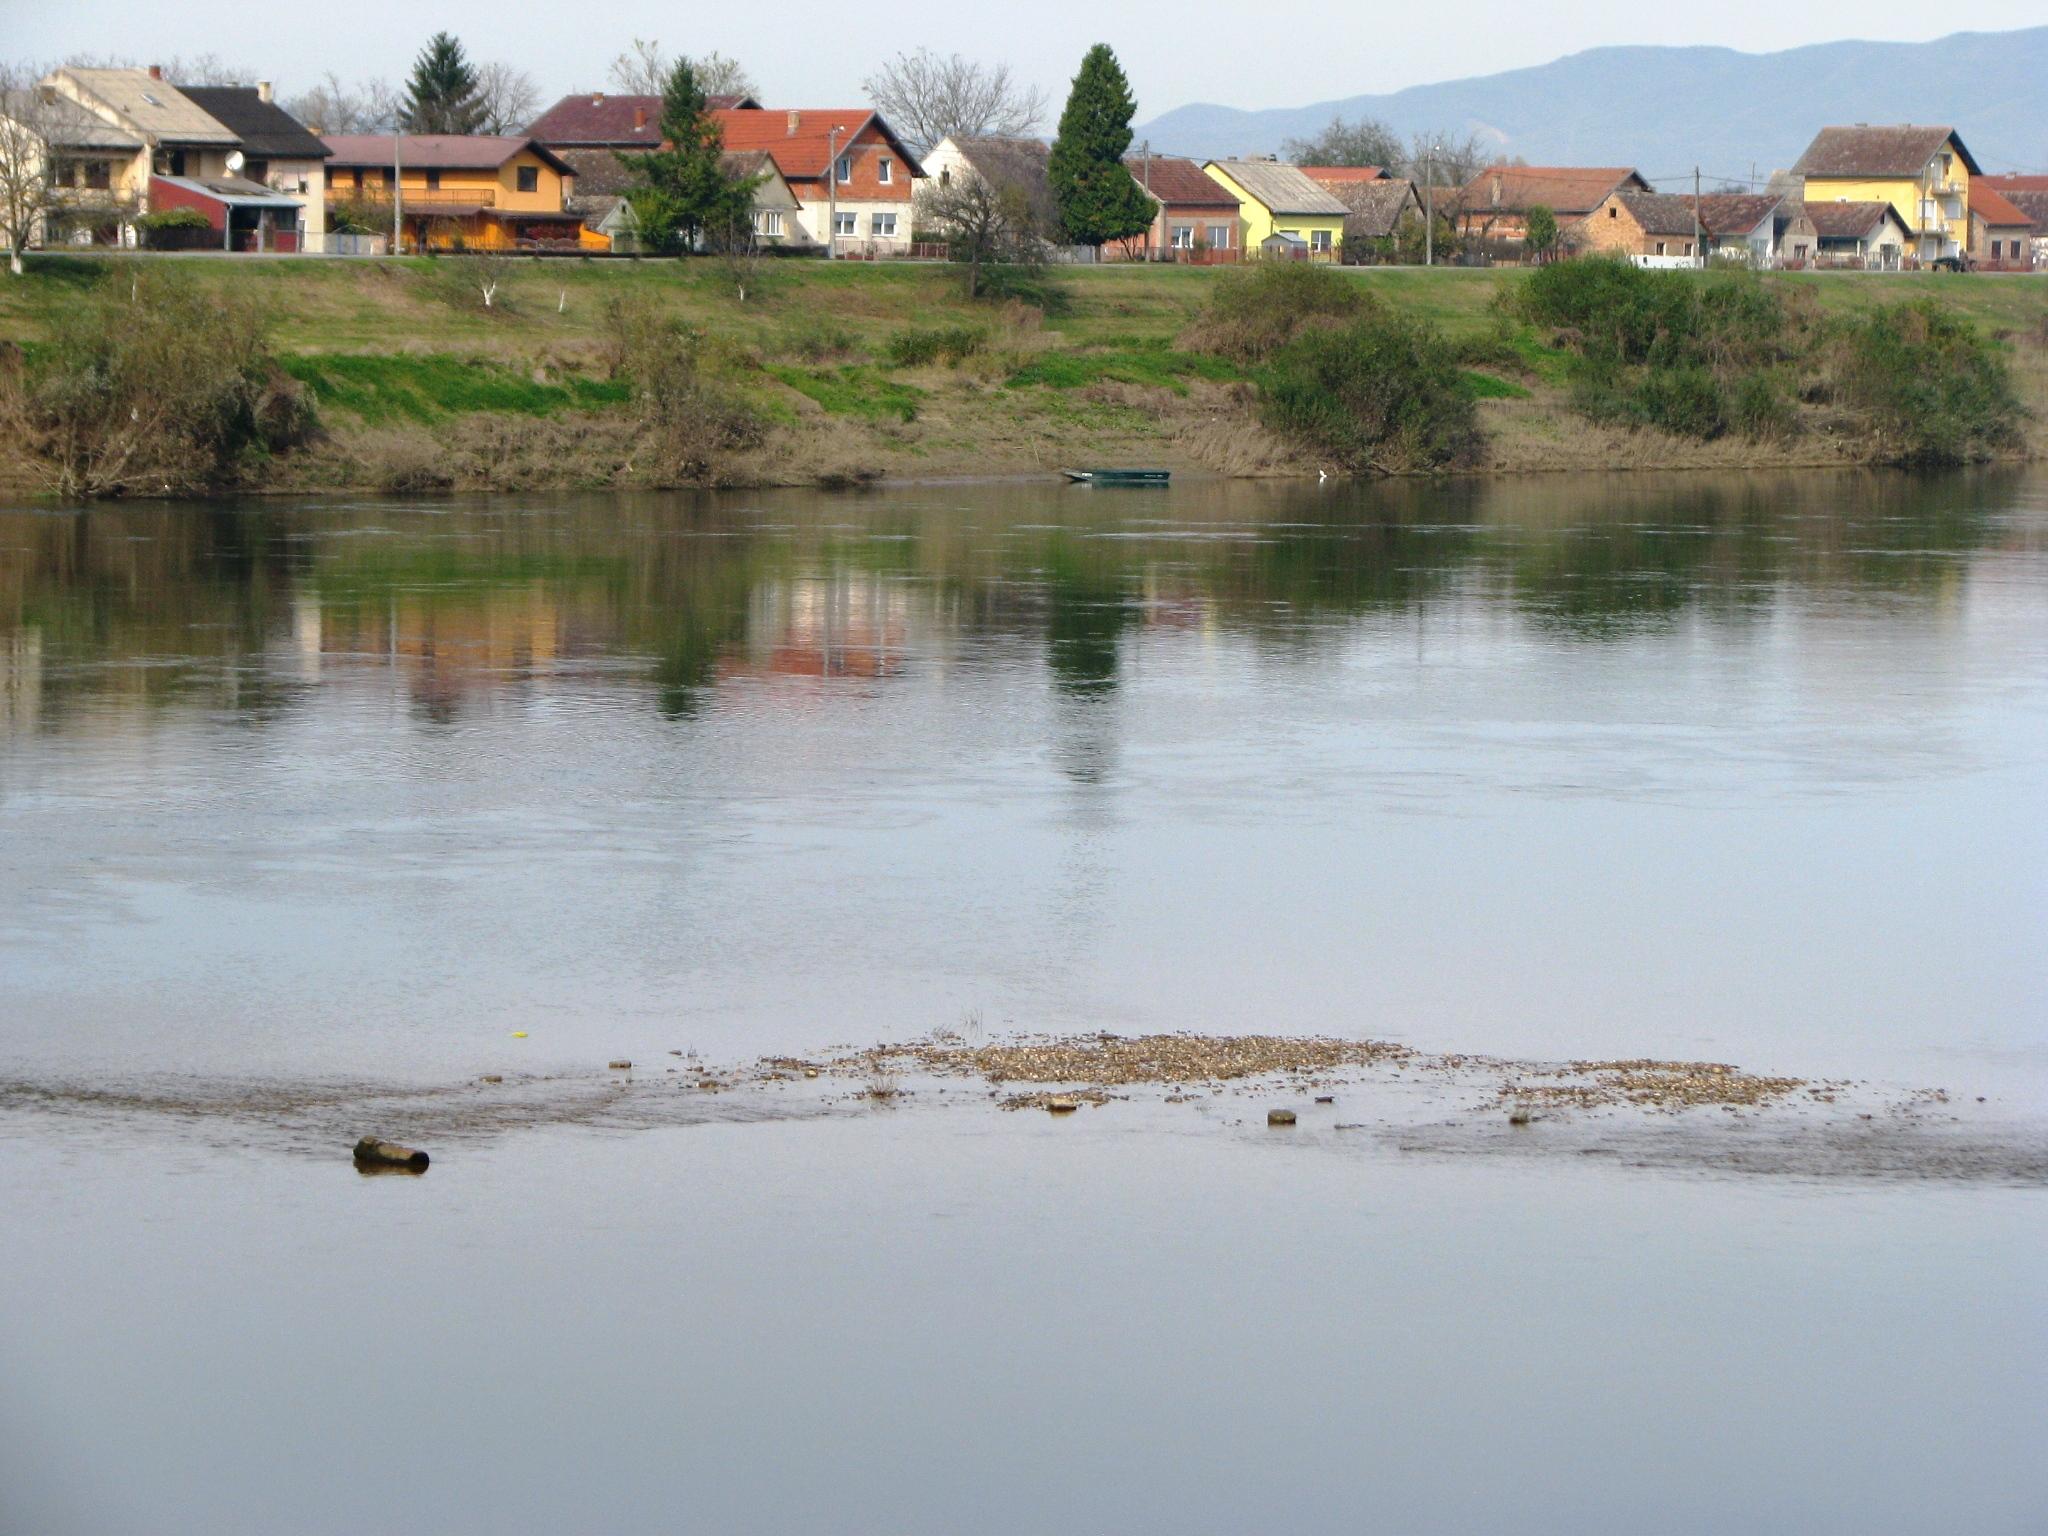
[0,256,2048,489]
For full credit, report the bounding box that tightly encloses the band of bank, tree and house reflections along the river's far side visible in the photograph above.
[0,475,2044,737]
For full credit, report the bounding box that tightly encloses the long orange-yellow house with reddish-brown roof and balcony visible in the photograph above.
[326,133,584,250]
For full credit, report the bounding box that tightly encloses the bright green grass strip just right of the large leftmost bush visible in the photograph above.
[285,352,631,424]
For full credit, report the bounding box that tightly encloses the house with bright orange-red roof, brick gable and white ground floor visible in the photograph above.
[713,106,924,256]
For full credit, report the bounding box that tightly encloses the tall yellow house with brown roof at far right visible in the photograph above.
[1792,123,1982,260]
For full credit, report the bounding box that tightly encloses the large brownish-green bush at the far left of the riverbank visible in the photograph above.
[0,266,315,498]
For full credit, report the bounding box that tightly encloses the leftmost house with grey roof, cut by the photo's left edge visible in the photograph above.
[0,86,150,246]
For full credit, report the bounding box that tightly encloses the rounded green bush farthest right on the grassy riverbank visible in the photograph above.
[1831,299,2025,465]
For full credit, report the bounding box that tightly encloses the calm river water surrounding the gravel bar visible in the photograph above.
[0,475,2048,1532]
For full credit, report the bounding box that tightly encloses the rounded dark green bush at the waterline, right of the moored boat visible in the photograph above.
[1260,313,1483,473]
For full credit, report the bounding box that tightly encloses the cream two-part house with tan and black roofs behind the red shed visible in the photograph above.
[41,66,326,250]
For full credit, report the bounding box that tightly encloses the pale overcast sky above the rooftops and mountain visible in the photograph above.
[0,0,2044,121]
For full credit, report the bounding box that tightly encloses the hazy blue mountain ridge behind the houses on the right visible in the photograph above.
[1137,27,2048,184]
